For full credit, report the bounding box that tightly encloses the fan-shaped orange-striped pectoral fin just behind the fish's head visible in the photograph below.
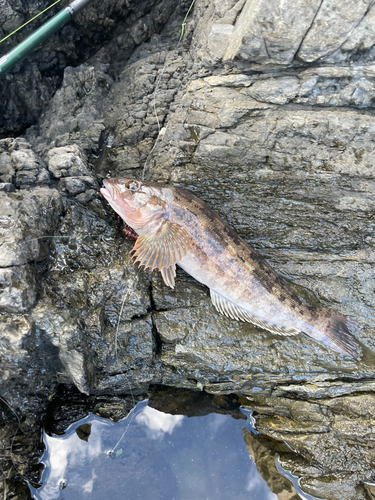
[132,221,190,270]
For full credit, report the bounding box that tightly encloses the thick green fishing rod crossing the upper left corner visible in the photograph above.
[0,0,91,76]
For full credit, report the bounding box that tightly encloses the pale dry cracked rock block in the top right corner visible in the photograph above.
[195,0,374,67]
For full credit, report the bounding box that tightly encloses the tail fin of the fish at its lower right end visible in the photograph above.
[303,308,358,358]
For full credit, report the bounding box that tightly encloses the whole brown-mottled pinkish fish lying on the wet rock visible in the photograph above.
[100,178,358,358]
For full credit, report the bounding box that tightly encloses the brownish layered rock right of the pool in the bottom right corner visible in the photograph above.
[242,394,375,500]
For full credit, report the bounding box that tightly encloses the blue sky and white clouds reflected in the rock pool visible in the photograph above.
[31,401,278,500]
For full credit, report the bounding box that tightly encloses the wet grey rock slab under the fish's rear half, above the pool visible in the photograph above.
[154,296,373,395]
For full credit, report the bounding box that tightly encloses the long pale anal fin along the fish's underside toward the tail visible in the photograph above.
[210,290,301,335]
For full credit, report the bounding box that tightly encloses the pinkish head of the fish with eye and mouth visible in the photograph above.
[100,178,168,234]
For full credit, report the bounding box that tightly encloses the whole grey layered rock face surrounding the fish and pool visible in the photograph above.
[0,0,375,500]
